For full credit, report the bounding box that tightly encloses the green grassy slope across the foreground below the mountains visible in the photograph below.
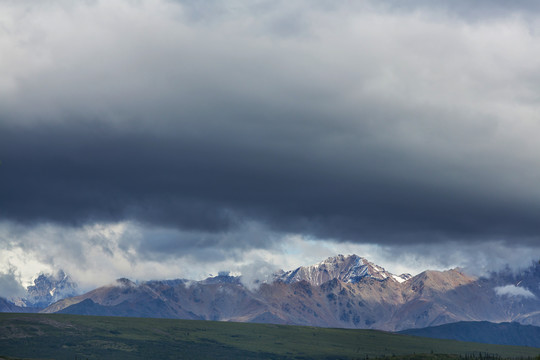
[0,313,540,360]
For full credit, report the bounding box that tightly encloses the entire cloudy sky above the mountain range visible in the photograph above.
[0,0,540,296]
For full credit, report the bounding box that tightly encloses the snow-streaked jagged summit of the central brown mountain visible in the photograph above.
[278,254,404,285]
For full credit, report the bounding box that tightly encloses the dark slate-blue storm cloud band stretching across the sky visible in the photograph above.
[4,108,540,246]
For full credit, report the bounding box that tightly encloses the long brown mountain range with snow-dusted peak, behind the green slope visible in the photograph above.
[38,255,540,331]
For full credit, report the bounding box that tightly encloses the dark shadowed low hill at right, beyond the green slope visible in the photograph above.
[400,321,540,348]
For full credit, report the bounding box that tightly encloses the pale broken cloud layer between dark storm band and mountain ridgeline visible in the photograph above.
[0,222,538,290]
